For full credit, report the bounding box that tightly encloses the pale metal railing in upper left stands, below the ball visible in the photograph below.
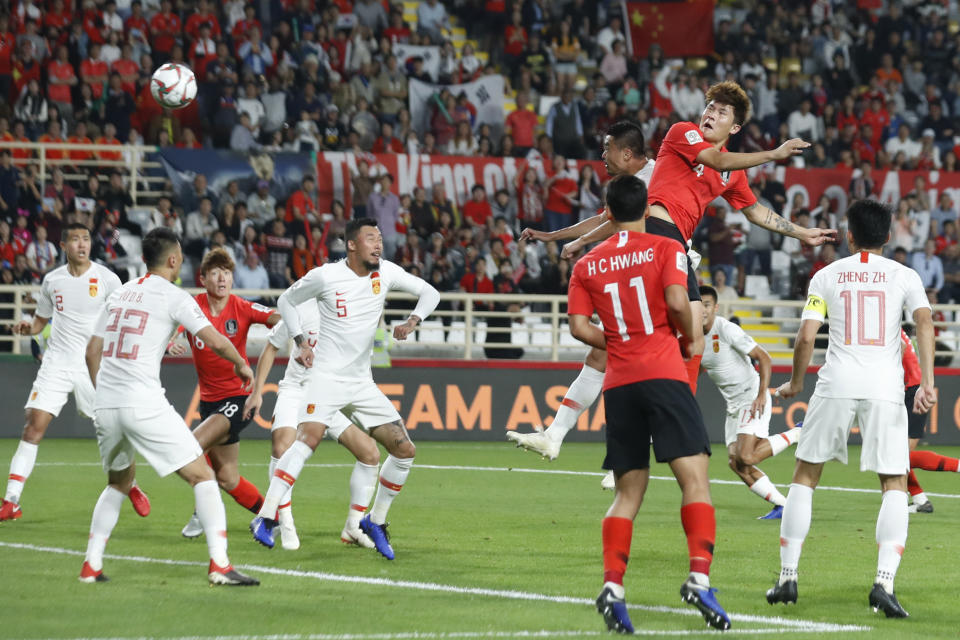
[0,141,169,205]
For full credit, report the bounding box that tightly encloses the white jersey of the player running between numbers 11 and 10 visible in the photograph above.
[700,316,760,409]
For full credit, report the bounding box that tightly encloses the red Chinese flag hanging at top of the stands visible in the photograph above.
[624,0,714,58]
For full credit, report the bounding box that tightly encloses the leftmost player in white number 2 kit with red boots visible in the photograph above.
[0,222,150,522]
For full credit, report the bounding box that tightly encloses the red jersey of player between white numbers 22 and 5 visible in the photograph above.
[187,293,273,402]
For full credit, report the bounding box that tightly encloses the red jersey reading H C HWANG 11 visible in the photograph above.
[567,231,688,390]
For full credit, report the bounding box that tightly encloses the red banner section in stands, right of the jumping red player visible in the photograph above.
[778,168,960,218]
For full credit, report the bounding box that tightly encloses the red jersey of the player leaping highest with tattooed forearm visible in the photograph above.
[647,122,757,240]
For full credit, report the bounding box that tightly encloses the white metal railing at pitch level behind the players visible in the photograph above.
[0,285,960,364]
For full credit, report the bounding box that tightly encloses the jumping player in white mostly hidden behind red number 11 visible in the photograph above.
[507,122,654,489]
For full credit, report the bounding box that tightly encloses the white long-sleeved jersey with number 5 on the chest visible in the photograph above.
[277,260,440,380]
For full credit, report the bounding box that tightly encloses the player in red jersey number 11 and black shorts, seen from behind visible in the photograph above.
[568,175,730,633]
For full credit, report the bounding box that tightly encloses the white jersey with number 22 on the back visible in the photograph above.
[94,273,210,409]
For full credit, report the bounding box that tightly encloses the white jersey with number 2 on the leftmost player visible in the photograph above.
[37,262,120,371]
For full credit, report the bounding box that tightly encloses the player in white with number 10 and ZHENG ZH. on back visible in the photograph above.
[767,200,937,618]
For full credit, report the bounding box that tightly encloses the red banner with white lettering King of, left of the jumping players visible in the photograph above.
[317,151,607,216]
